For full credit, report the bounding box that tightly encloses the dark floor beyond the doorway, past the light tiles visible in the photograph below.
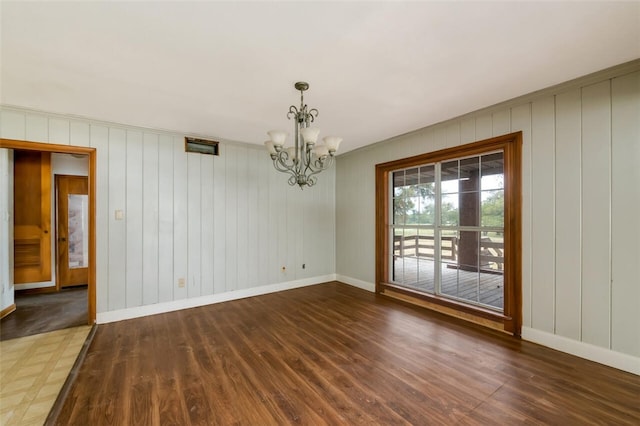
[0,286,89,340]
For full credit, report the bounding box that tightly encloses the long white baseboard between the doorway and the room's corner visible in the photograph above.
[96,274,336,324]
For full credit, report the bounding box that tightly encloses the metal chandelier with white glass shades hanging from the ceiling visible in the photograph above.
[264,81,342,189]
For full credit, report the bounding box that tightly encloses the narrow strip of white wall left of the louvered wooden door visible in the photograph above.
[0,149,14,311]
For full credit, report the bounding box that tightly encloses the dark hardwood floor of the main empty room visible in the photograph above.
[55,282,640,425]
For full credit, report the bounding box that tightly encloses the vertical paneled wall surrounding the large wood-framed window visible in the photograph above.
[336,67,640,357]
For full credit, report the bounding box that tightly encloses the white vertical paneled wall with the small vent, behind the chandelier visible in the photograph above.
[0,107,335,313]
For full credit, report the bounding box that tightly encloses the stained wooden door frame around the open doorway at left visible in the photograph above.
[0,138,97,325]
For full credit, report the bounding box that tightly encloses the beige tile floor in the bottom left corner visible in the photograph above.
[0,325,91,426]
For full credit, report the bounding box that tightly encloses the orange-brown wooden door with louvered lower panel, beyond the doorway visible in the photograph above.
[13,150,51,284]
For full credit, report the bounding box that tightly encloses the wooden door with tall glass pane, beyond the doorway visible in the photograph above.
[56,175,89,287]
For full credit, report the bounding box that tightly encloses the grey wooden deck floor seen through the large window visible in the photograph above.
[394,257,504,311]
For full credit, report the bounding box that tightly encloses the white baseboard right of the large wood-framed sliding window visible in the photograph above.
[522,327,640,375]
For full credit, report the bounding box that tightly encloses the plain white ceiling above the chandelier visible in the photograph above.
[0,0,640,152]
